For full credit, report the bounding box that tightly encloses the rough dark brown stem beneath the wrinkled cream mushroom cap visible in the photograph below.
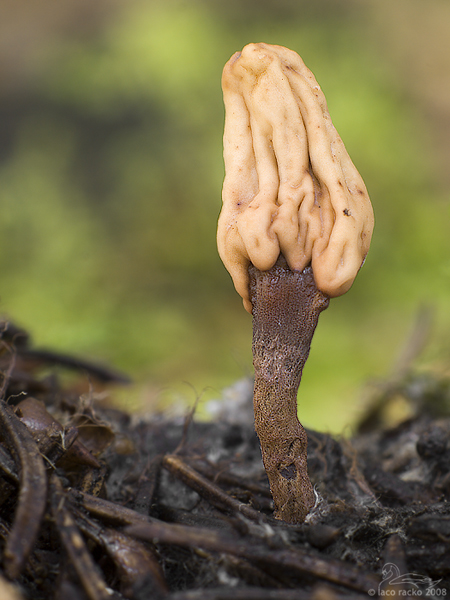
[249,255,329,523]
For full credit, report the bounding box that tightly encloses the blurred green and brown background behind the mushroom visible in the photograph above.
[0,0,450,431]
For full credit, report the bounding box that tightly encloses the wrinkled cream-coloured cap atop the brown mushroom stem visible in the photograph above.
[217,44,373,311]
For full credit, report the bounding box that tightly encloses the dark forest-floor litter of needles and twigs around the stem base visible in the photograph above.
[0,322,450,600]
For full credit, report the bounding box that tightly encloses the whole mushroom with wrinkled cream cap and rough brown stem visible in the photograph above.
[217,43,373,523]
